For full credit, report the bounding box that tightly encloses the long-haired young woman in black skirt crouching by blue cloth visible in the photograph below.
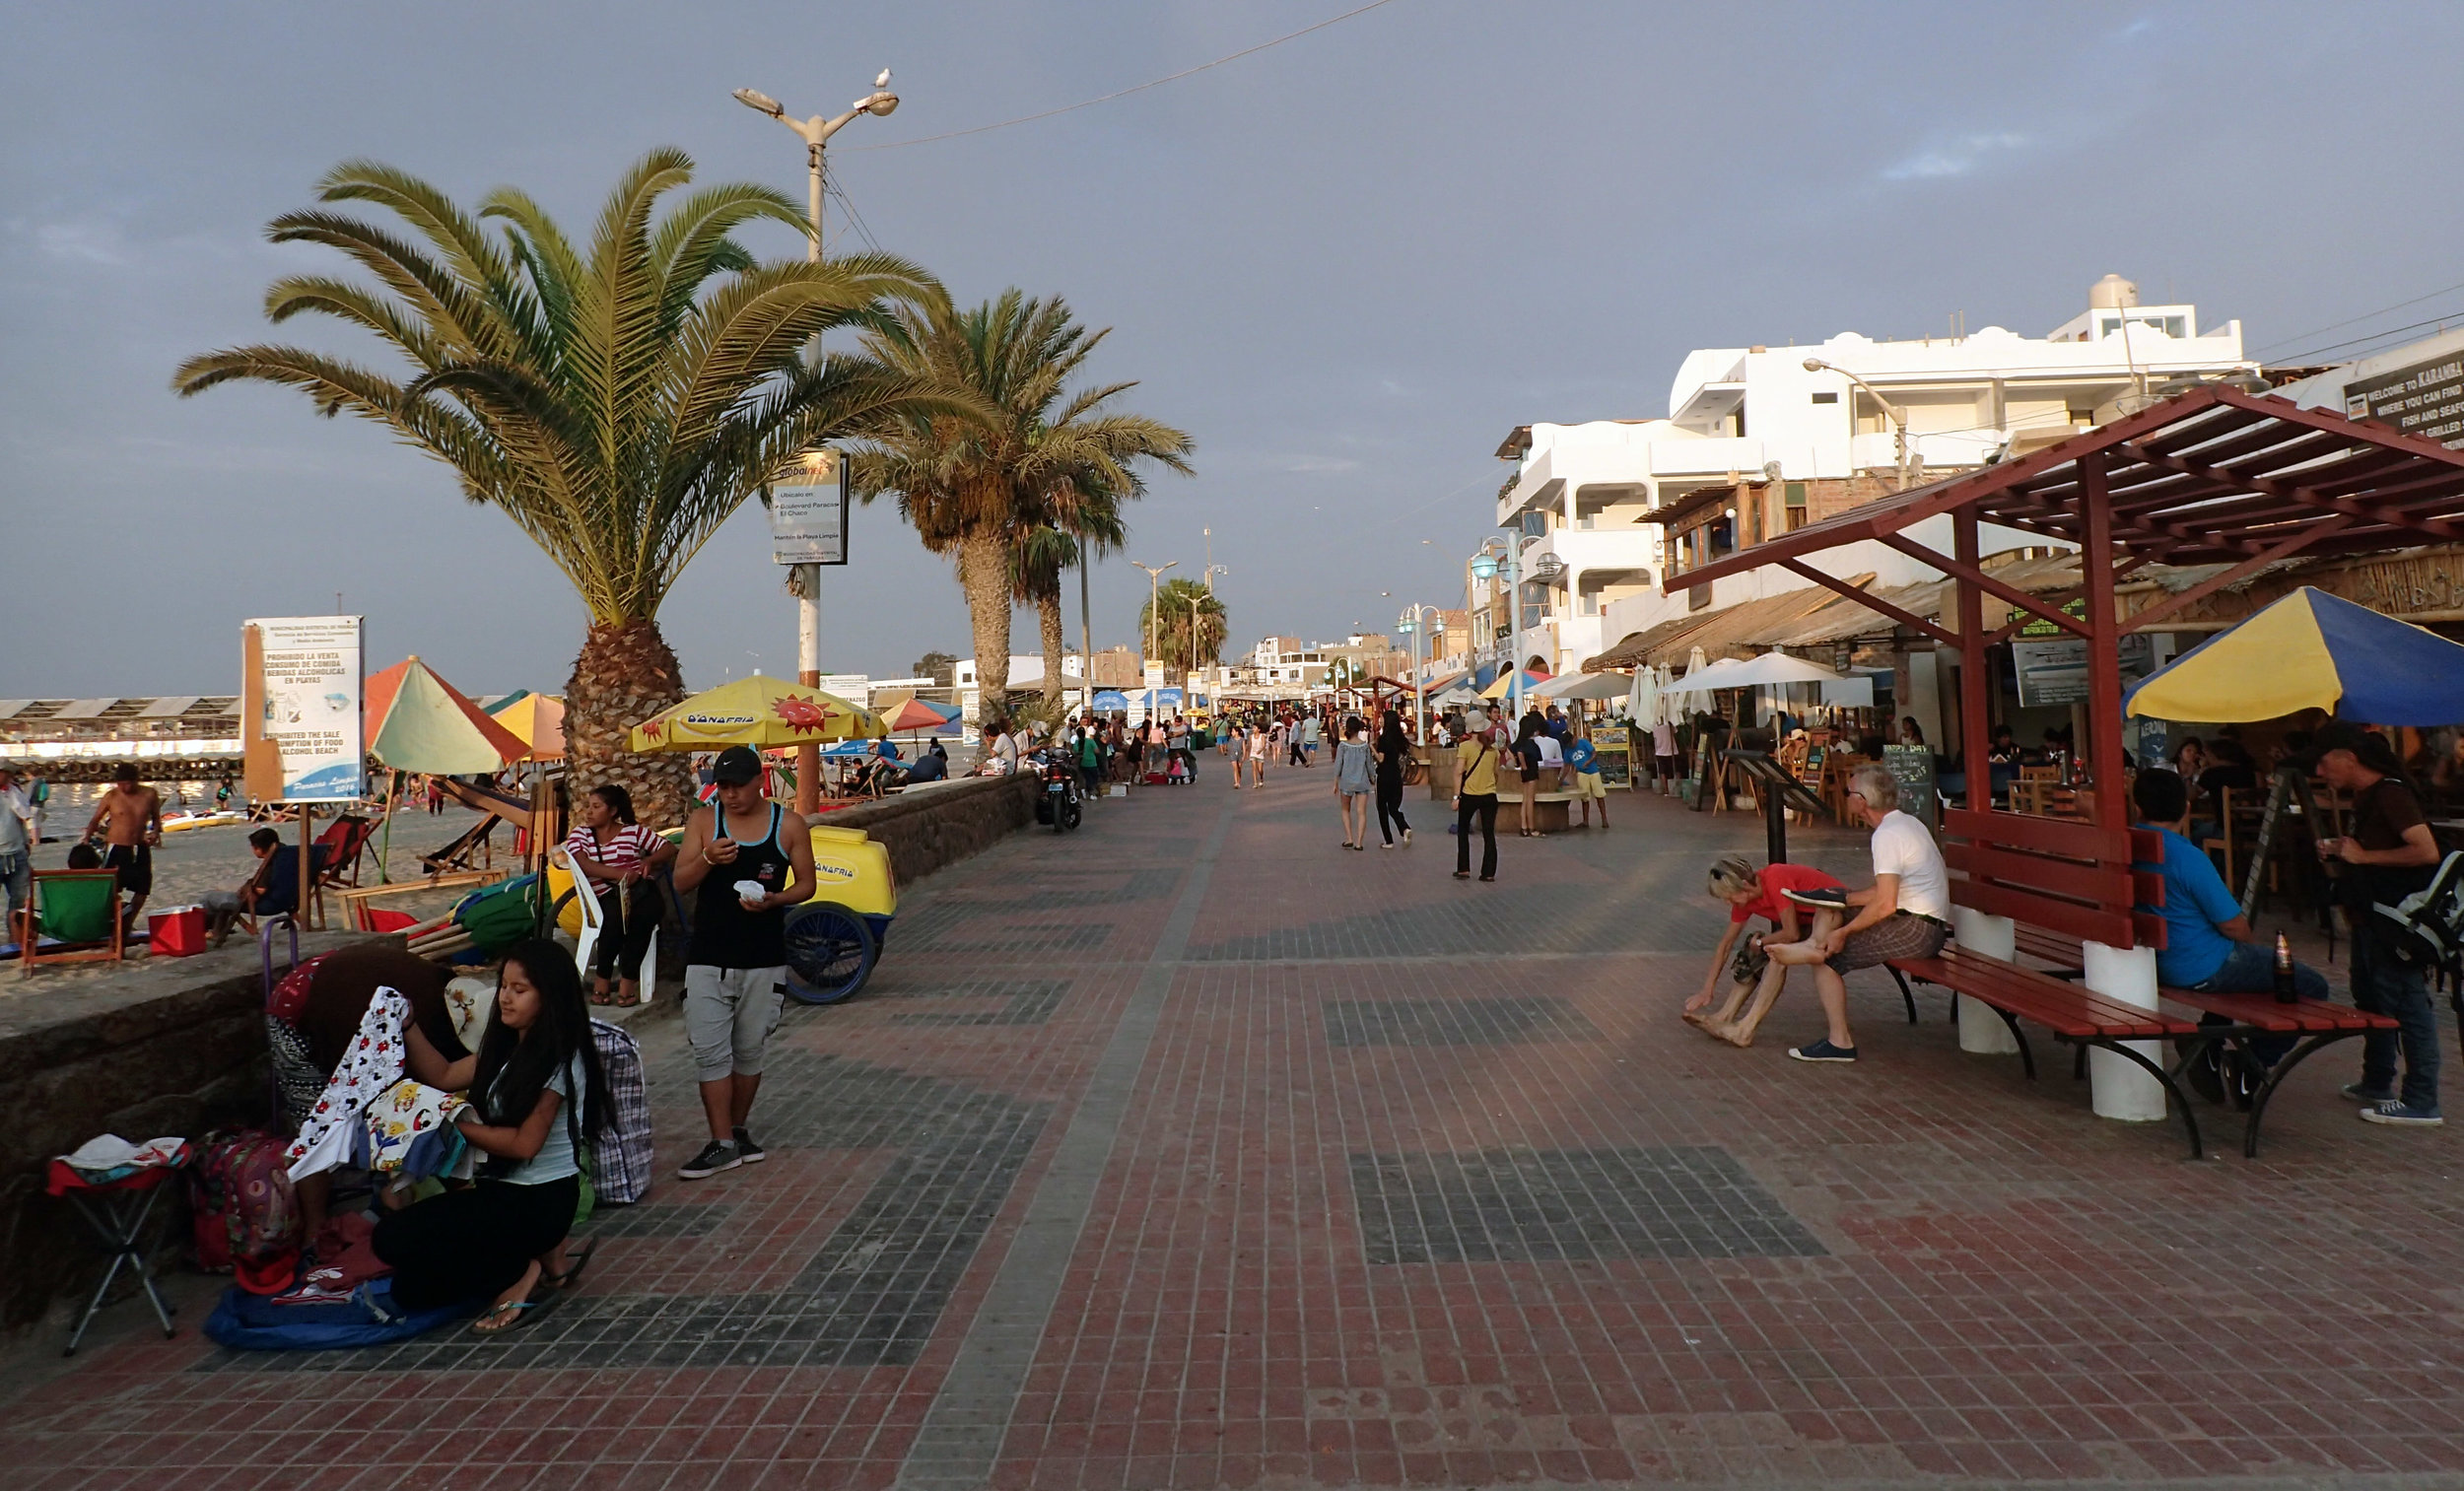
[363,939,614,1335]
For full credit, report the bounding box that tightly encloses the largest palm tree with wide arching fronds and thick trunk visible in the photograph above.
[172,151,969,823]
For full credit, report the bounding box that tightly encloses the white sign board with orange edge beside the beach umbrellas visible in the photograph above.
[240,616,368,803]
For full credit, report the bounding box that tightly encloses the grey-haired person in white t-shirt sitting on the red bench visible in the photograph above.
[1762,764,1951,1062]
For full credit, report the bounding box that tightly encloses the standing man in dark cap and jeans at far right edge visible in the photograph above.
[2311,719,2444,1128]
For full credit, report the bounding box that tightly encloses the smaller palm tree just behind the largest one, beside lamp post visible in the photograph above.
[851,289,1193,724]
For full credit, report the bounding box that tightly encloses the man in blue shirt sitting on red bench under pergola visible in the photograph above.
[2132,772,2326,1084]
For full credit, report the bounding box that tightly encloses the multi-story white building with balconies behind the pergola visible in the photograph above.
[1467,276,2257,670]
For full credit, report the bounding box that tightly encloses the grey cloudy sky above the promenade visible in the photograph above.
[0,0,2464,695]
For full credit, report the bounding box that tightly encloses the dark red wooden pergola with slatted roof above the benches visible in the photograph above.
[1683,387,2464,946]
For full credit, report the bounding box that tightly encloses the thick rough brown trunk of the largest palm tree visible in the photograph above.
[565,621,693,828]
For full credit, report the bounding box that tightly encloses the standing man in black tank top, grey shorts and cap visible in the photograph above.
[675,747,813,1181]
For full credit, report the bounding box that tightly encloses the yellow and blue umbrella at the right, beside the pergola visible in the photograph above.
[2124,584,2464,724]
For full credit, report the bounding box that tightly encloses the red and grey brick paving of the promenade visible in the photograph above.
[0,759,2464,1491]
